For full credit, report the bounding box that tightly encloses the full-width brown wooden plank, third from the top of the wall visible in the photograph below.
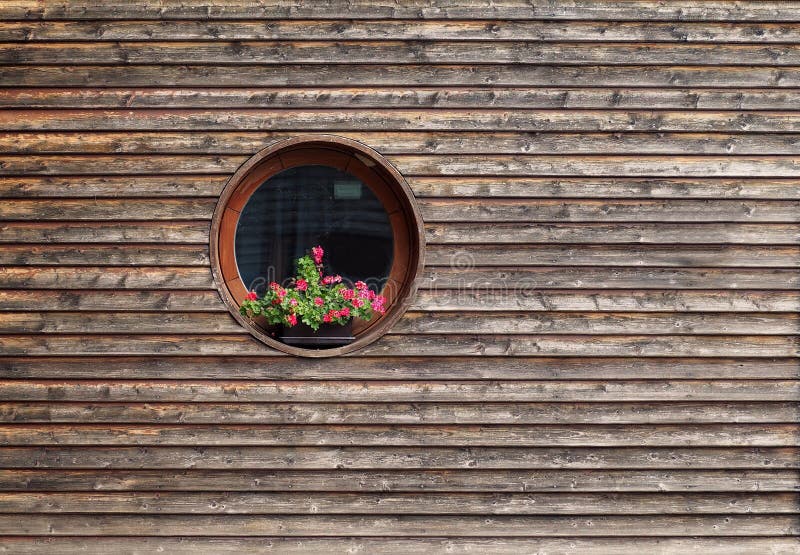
[7,41,800,67]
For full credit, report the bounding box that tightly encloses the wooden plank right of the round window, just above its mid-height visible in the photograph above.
[428,223,800,245]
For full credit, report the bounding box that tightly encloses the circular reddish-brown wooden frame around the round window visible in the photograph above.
[209,135,425,358]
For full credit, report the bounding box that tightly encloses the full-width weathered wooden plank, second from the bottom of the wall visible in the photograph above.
[0,514,800,537]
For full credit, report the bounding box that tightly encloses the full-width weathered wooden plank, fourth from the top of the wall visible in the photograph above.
[0,64,800,88]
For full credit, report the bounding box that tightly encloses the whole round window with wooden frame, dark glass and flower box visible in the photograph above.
[210,135,424,357]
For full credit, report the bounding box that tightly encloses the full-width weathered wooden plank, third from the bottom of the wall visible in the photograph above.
[0,492,800,515]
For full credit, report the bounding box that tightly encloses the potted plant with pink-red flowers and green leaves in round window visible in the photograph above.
[239,246,386,347]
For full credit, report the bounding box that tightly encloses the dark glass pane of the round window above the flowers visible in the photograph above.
[235,165,393,293]
